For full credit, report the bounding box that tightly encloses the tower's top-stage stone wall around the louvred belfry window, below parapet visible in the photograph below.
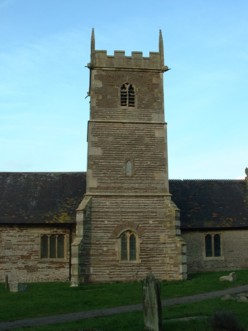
[90,70,164,122]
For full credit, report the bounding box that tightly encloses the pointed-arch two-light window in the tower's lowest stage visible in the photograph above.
[120,230,137,261]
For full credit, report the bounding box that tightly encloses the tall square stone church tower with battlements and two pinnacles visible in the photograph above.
[71,30,186,285]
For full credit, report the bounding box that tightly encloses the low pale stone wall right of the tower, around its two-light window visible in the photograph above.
[182,230,248,272]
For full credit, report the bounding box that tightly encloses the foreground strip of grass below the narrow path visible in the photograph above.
[12,298,248,331]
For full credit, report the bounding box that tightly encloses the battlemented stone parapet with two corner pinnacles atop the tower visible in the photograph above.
[88,30,169,72]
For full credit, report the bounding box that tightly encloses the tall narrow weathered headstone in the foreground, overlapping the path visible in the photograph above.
[143,273,162,331]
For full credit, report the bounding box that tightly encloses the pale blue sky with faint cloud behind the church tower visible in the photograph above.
[0,0,248,179]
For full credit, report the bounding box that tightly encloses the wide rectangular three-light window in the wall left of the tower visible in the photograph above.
[40,234,66,259]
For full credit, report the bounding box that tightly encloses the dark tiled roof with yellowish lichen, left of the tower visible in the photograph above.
[0,173,86,224]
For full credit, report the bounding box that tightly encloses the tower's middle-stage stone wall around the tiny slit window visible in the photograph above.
[87,122,168,194]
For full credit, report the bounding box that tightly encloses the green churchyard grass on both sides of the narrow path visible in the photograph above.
[0,270,248,331]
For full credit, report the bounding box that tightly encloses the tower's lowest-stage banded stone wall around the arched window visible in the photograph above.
[79,196,186,282]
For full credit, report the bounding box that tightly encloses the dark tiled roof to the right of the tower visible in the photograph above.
[170,180,248,229]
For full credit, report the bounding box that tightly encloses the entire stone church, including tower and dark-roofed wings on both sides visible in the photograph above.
[0,30,248,286]
